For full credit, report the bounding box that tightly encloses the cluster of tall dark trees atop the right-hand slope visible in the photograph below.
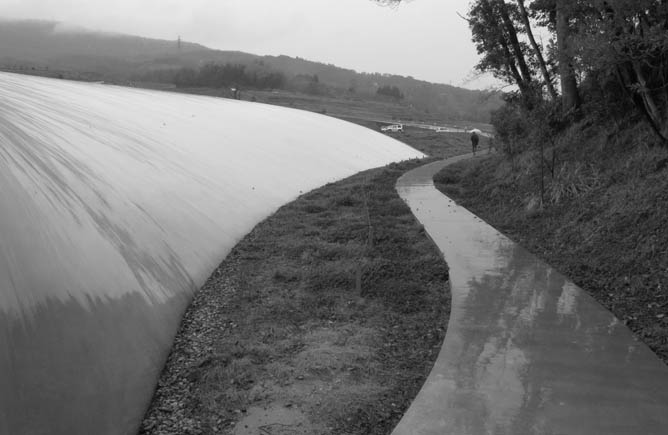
[376,0,668,146]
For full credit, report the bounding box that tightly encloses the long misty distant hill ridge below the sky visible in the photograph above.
[0,21,501,122]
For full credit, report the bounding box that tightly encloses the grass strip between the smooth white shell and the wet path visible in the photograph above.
[141,135,462,434]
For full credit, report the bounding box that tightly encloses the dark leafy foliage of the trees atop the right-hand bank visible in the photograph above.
[482,0,668,150]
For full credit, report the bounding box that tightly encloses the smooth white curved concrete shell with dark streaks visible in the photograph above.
[0,74,422,435]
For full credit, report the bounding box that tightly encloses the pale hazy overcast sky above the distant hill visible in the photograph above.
[0,0,492,88]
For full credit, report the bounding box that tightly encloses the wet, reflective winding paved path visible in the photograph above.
[393,157,668,435]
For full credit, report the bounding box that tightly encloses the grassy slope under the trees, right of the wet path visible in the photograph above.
[435,129,668,362]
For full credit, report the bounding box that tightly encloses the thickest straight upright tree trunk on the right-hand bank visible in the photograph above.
[556,0,580,112]
